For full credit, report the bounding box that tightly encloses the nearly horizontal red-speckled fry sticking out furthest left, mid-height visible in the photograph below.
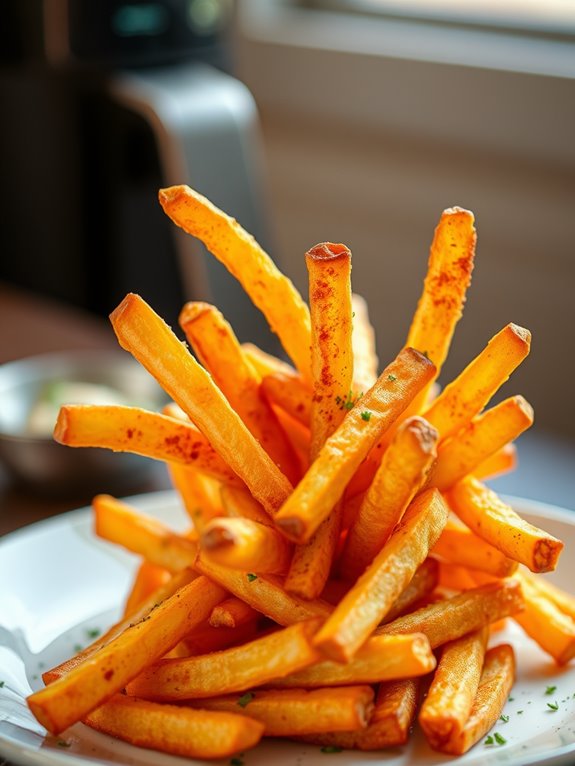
[54,404,243,486]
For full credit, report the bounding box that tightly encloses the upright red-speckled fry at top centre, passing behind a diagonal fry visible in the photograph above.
[285,242,353,598]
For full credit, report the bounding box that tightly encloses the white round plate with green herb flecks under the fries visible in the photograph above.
[0,492,575,766]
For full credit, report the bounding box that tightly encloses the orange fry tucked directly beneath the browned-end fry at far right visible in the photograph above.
[431,519,517,577]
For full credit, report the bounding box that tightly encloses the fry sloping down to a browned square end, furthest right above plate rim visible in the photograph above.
[448,477,563,572]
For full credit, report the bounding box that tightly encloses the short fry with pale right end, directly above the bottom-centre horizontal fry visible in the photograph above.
[270,633,436,689]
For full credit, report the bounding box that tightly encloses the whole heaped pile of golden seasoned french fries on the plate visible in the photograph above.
[28,186,575,758]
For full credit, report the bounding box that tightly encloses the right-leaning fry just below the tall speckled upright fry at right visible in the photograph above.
[423,324,531,440]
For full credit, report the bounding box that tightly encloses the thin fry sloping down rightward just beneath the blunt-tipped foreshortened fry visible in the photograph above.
[195,553,332,625]
